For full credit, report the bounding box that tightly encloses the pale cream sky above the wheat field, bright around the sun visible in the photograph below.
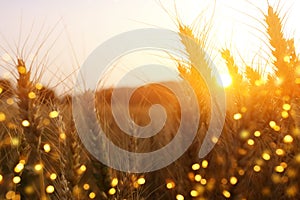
[0,0,300,92]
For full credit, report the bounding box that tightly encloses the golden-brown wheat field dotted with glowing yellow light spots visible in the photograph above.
[0,1,300,200]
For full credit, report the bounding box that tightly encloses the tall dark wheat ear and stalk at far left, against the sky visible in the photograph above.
[16,59,46,199]
